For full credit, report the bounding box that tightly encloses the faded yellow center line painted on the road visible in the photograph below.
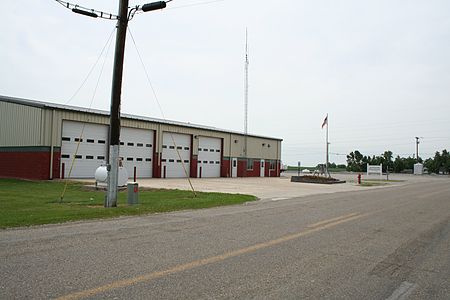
[57,213,368,300]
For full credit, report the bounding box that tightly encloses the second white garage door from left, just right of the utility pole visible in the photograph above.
[119,127,154,178]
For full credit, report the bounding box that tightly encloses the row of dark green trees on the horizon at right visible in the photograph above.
[347,149,450,174]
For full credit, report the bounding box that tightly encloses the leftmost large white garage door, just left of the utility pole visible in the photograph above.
[61,121,108,178]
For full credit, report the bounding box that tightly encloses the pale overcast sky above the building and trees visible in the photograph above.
[0,0,450,166]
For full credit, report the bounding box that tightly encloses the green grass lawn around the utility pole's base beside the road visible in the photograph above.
[0,179,256,228]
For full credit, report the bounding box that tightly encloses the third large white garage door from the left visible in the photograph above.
[161,132,191,178]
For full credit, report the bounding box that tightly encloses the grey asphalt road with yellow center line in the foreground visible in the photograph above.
[0,180,450,300]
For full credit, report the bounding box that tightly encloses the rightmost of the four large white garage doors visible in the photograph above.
[197,137,222,178]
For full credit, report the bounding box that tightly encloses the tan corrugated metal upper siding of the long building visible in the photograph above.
[0,102,281,160]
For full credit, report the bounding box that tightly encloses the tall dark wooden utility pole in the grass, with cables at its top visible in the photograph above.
[56,0,172,207]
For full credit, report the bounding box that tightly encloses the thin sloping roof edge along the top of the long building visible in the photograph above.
[0,95,283,141]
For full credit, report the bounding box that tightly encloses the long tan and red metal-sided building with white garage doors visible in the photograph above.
[0,96,282,180]
